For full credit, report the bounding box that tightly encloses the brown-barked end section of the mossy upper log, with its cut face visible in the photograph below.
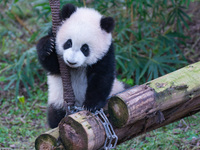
[108,85,155,127]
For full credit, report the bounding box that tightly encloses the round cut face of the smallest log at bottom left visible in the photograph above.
[35,134,57,150]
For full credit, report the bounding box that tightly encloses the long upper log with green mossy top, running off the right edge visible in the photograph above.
[108,62,200,127]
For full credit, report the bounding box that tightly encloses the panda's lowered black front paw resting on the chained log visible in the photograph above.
[83,101,107,112]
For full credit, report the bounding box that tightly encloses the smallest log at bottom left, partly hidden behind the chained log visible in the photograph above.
[35,127,59,150]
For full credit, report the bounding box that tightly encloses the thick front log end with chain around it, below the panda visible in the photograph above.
[59,111,105,150]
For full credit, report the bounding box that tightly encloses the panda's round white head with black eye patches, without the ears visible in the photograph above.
[56,8,112,68]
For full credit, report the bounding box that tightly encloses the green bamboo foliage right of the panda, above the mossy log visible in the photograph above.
[107,0,190,84]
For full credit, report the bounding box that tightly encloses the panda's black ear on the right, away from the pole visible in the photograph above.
[100,17,115,33]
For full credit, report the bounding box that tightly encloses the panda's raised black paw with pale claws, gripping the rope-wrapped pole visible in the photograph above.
[37,36,55,60]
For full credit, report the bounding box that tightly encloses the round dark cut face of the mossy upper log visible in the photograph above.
[108,96,129,127]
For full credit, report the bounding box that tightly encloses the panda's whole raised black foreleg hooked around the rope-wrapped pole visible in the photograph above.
[36,35,60,74]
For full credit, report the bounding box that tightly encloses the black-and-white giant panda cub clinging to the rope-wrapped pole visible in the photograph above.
[37,4,125,128]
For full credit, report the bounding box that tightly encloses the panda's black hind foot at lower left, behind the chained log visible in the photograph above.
[47,105,66,128]
